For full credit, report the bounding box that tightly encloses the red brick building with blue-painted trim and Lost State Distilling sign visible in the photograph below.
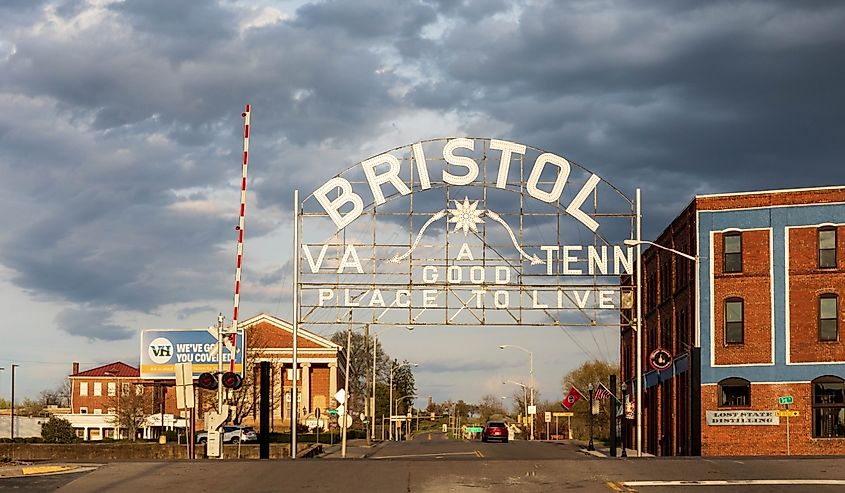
[621,187,845,456]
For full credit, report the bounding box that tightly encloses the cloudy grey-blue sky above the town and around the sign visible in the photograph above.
[0,0,845,401]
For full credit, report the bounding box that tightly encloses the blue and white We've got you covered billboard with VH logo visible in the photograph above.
[140,329,244,379]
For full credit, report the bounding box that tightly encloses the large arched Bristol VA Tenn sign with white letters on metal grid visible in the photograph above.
[294,137,639,327]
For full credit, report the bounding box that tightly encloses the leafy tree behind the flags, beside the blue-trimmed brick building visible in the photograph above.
[561,360,619,439]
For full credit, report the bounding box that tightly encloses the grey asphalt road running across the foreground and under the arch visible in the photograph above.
[0,436,845,493]
